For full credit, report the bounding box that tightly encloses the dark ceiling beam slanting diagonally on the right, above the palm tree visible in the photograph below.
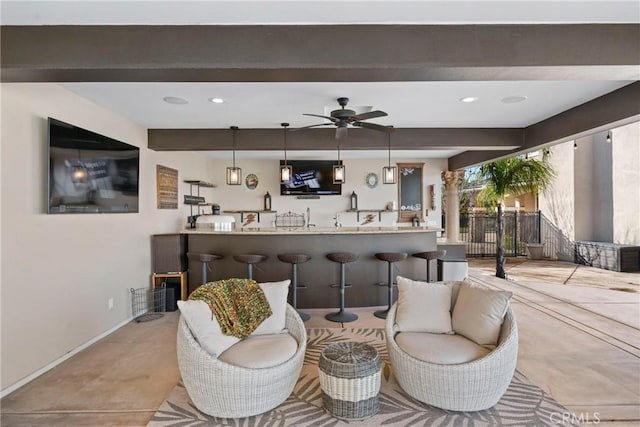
[449,82,640,170]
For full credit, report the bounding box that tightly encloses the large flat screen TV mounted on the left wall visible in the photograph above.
[47,117,140,214]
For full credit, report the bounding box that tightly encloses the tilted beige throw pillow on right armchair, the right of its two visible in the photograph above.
[451,283,513,349]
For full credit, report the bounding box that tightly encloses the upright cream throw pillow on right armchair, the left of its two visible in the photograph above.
[396,276,453,334]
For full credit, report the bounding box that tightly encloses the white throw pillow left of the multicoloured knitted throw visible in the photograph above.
[178,300,240,356]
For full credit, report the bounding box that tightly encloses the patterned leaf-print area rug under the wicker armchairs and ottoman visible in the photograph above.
[148,328,569,427]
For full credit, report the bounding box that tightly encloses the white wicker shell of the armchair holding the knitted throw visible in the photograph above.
[177,305,307,418]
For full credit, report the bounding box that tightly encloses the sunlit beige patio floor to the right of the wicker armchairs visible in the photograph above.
[469,258,640,426]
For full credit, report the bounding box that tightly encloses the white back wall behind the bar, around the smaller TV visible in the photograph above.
[206,158,447,231]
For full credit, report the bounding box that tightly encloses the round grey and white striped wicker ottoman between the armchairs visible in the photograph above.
[318,342,380,420]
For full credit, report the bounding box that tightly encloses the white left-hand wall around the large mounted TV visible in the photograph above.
[1,84,212,392]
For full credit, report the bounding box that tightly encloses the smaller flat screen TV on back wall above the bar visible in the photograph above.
[280,160,342,196]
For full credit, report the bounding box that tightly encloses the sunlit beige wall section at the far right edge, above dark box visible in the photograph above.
[611,122,640,245]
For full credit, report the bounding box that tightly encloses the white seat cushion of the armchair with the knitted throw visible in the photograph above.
[218,333,298,369]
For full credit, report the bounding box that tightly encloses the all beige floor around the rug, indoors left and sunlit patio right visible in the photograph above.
[0,260,640,427]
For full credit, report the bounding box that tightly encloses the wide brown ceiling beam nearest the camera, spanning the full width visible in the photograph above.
[0,24,640,82]
